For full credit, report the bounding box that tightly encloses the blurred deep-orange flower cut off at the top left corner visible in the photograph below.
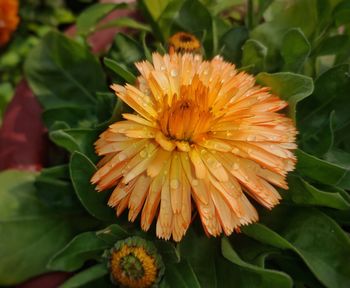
[0,0,19,46]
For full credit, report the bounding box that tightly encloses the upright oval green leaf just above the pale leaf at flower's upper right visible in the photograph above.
[281,28,311,73]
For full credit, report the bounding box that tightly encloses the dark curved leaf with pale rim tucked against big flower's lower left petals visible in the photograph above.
[69,152,116,221]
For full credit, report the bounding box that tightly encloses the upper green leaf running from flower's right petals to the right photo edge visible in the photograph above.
[296,149,350,189]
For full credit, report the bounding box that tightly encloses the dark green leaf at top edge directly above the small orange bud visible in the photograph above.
[175,0,212,32]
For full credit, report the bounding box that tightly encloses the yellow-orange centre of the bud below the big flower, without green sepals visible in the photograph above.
[110,245,158,288]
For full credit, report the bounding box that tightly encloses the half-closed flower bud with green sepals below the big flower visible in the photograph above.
[106,237,164,288]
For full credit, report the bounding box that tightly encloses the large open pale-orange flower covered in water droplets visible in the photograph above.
[92,53,296,241]
